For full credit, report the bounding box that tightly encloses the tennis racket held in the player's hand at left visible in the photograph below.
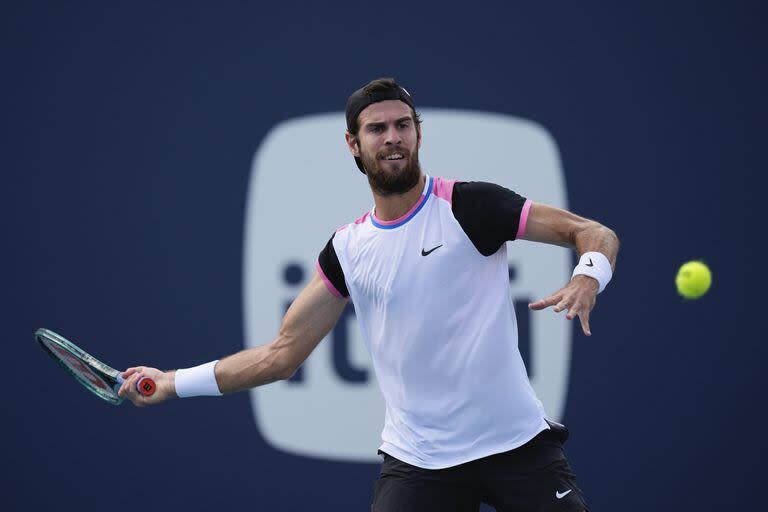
[35,329,157,405]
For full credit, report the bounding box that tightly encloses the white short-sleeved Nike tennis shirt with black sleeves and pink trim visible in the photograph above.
[318,177,549,469]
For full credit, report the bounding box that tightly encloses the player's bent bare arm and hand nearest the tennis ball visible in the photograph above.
[523,203,619,336]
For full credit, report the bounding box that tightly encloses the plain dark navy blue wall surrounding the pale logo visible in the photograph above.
[0,2,768,511]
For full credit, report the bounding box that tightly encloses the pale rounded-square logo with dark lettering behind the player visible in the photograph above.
[244,109,573,462]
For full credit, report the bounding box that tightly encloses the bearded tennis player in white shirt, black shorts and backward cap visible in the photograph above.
[120,79,619,512]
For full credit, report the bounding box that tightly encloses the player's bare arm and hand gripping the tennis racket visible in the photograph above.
[119,273,347,406]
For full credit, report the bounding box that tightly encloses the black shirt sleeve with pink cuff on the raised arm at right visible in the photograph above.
[452,181,526,256]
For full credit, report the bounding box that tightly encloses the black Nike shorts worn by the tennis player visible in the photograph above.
[371,422,587,512]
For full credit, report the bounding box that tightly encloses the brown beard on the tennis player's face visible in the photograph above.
[361,148,421,196]
